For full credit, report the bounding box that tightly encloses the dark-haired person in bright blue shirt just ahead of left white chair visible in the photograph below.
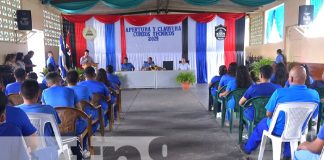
[42,72,76,108]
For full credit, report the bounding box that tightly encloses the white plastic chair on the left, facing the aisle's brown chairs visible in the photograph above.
[26,113,71,160]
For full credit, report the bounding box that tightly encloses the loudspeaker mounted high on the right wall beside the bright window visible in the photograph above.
[298,5,314,25]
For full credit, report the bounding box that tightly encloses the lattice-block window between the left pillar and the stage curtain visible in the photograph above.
[43,10,61,46]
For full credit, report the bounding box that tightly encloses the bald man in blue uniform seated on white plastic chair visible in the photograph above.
[240,66,320,159]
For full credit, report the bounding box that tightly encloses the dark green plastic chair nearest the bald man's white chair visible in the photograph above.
[238,97,270,144]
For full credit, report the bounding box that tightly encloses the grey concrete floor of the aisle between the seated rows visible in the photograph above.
[100,85,272,160]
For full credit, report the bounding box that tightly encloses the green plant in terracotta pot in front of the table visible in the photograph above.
[176,72,196,91]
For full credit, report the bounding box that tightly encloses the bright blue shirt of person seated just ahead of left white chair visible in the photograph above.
[42,86,76,108]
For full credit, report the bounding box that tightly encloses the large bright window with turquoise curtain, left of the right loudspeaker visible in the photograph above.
[264,4,285,43]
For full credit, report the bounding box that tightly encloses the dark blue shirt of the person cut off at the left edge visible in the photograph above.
[6,107,36,136]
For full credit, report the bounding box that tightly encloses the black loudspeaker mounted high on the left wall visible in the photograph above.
[17,10,33,30]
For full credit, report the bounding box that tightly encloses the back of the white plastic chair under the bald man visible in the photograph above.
[269,102,317,141]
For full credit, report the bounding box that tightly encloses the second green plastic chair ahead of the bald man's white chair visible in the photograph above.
[222,88,246,133]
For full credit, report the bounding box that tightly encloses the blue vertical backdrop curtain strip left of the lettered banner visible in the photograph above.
[105,24,116,69]
